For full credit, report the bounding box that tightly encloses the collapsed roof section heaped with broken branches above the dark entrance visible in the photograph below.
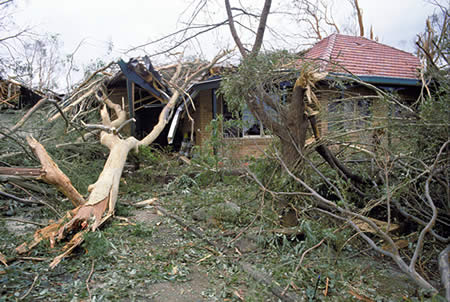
[49,57,229,146]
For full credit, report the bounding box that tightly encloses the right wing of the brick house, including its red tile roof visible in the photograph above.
[304,34,421,143]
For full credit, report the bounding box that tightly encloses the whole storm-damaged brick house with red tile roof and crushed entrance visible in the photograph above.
[101,34,421,158]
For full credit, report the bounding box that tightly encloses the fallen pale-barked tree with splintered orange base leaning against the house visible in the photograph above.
[16,52,227,268]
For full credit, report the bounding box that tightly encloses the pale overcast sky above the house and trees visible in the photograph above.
[9,0,440,86]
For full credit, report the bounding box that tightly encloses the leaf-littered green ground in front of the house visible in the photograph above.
[0,147,439,301]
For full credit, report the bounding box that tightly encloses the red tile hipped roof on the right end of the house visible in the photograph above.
[305,34,421,79]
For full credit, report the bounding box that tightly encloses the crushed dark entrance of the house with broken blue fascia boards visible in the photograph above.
[104,57,218,151]
